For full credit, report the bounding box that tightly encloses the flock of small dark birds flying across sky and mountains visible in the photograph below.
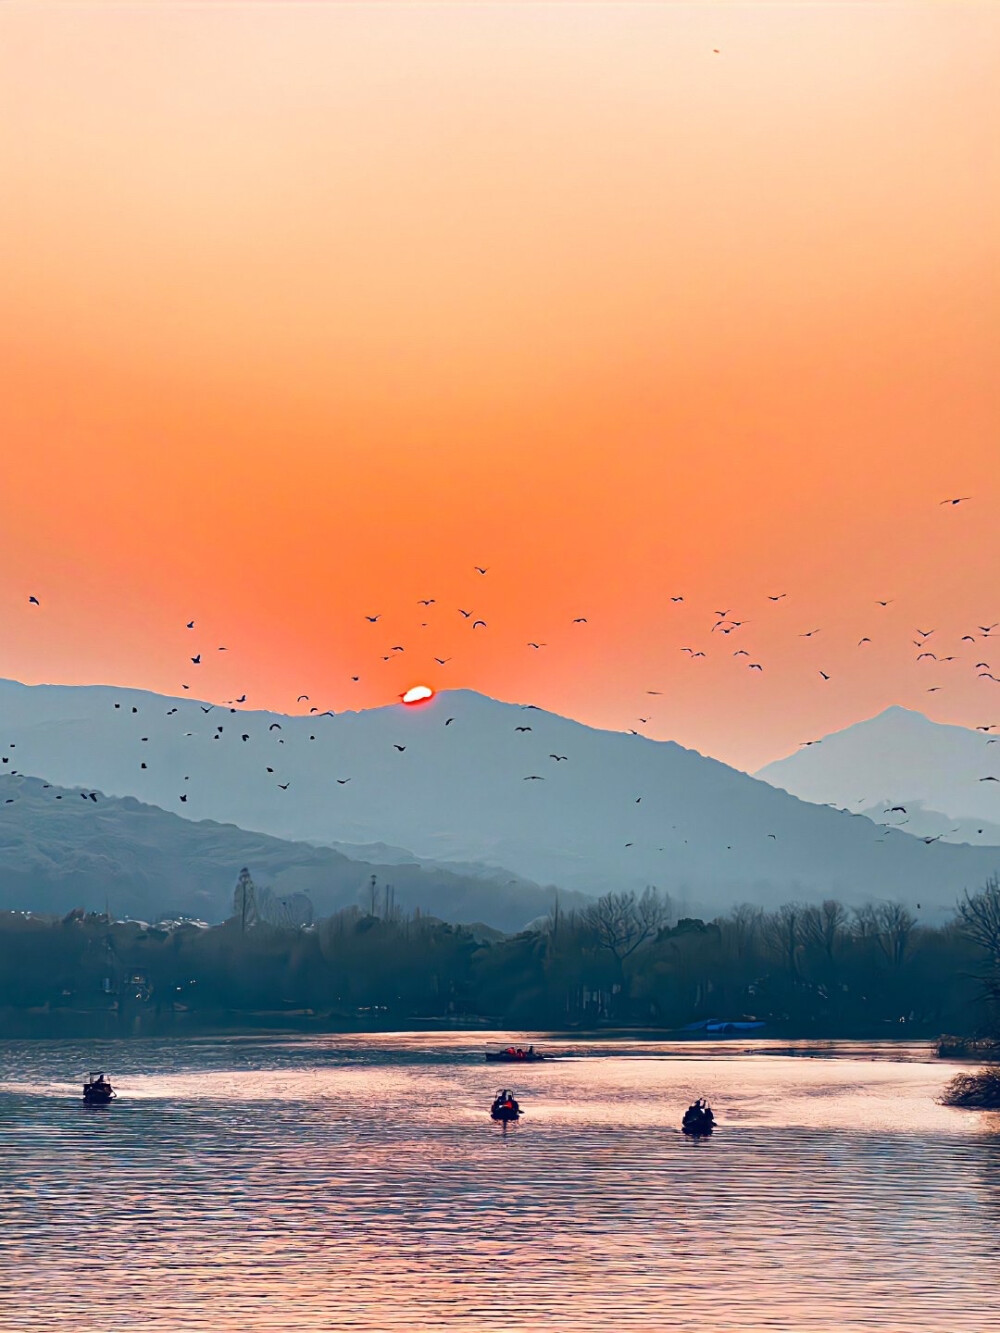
[3,496,1000,848]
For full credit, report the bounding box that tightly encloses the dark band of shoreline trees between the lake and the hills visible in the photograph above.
[0,872,1000,1040]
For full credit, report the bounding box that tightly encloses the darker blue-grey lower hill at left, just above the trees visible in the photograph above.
[0,777,570,930]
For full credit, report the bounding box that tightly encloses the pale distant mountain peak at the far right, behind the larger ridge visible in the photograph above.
[756,708,1000,842]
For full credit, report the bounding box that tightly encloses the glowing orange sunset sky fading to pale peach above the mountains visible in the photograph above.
[0,3,1000,766]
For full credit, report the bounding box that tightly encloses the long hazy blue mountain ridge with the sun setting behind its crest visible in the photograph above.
[0,682,1000,920]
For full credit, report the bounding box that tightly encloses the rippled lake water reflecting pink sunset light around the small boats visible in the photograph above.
[0,1033,1000,1333]
